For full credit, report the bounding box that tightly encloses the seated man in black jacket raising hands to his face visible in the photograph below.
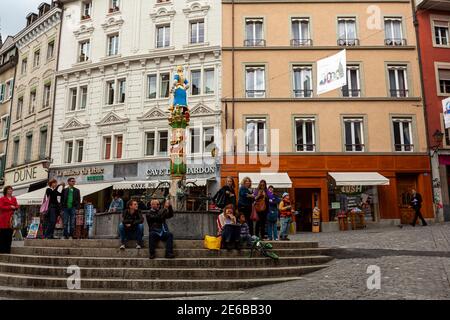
[146,200,175,259]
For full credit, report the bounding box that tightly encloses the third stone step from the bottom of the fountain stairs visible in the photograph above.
[0,263,328,279]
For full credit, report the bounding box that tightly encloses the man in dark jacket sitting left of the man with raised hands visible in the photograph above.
[119,200,144,250]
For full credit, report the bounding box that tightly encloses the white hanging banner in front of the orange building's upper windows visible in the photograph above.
[317,50,347,94]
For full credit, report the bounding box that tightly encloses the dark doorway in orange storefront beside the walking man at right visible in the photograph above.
[397,175,417,224]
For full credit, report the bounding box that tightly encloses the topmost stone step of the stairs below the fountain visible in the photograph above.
[24,239,319,249]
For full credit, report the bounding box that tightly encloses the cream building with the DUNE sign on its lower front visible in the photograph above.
[5,3,61,195]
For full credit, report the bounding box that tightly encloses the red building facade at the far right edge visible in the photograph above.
[416,0,450,221]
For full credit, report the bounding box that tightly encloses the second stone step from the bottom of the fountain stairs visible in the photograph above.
[0,273,301,291]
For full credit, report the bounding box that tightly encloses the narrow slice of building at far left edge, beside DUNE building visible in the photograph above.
[0,36,17,187]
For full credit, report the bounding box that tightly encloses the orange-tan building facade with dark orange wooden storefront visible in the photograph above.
[221,0,434,231]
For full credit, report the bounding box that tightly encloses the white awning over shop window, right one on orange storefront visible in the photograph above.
[329,172,389,186]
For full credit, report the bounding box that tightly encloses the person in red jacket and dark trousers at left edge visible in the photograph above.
[0,186,19,253]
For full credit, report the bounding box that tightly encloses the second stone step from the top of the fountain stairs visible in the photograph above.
[11,247,331,258]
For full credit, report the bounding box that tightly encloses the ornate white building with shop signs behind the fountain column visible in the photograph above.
[51,0,221,209]
